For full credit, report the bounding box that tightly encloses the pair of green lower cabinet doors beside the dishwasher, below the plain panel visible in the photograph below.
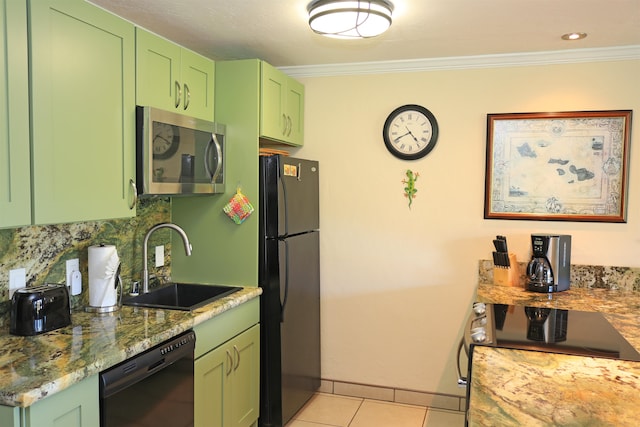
[194,325,260,427]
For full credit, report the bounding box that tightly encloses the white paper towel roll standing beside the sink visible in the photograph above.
[89,245,120,307]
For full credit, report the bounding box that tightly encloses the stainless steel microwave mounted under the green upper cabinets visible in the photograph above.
[136,106,225,196]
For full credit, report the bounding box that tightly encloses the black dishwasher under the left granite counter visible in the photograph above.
[100,331,196,427]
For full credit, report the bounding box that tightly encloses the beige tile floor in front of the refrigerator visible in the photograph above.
[286,393,464,427]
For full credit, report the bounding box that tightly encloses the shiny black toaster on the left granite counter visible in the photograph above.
[9,283,71,336]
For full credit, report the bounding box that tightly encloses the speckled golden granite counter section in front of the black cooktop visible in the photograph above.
[468,347,640,427]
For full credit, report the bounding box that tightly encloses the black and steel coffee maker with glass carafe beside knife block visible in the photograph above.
[527,234,571,293]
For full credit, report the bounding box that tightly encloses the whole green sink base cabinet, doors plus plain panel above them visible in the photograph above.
[194,298,260,427]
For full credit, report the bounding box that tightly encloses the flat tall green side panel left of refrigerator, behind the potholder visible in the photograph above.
[171,59,260,286]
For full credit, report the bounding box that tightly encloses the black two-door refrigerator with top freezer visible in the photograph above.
[259,155,320,427]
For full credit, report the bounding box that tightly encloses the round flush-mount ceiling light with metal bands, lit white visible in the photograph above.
[307,0,393,39]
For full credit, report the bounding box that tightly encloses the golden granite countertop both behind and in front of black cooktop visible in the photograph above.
[468,284,640,427]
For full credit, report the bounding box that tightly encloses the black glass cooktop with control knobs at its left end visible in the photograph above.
[470,304,640,361]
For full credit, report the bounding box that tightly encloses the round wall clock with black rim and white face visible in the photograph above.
[382,104,438,160]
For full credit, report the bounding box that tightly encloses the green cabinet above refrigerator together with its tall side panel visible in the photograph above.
[171,59,304,286]
